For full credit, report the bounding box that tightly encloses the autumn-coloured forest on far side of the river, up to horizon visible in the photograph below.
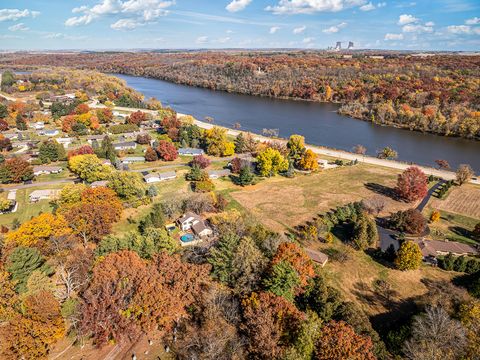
[0,52,480,139]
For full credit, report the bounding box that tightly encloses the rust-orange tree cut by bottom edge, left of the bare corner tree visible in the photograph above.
[315,321,376,360]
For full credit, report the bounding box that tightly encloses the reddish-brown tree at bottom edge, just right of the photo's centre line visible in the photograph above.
[242,292,303,359]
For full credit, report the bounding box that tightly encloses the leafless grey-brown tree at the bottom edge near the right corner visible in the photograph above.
[404,306,467,360]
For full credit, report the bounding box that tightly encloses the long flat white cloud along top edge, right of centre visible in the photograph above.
[265,0,366,15]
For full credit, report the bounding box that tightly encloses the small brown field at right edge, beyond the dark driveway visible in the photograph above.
[430,184,480,221]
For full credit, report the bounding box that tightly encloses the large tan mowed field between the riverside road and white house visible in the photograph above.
[230,164,413,231]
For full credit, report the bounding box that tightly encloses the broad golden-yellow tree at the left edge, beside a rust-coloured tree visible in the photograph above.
[5,213,72,246]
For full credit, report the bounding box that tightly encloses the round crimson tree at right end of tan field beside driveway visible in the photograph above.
[395,166,428,202]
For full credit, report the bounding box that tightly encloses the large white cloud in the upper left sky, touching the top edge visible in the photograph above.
[65,0,175,30]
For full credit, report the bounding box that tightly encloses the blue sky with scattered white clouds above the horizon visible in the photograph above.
[0,0,480,50]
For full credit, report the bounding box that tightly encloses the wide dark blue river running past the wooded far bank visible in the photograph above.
[116,74,480,173]
